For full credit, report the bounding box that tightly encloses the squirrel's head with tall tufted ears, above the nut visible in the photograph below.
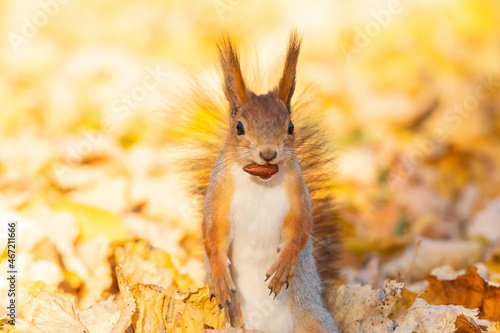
[217,31,301,165]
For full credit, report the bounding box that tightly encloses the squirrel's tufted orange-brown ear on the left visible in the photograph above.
[217,37,250,117]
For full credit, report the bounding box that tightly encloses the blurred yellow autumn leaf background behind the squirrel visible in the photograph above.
[0,0,500,320]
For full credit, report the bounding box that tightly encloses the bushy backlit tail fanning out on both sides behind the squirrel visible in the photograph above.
[162,66,338,291]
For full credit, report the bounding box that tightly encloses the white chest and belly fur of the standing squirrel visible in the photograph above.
[229,168,293,333]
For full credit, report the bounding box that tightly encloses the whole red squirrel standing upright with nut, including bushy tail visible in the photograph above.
[166,30,338,333]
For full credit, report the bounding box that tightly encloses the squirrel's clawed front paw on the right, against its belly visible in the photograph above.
[266,249,297,299]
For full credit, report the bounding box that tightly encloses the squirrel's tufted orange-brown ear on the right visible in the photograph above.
[273,30,302,111]
